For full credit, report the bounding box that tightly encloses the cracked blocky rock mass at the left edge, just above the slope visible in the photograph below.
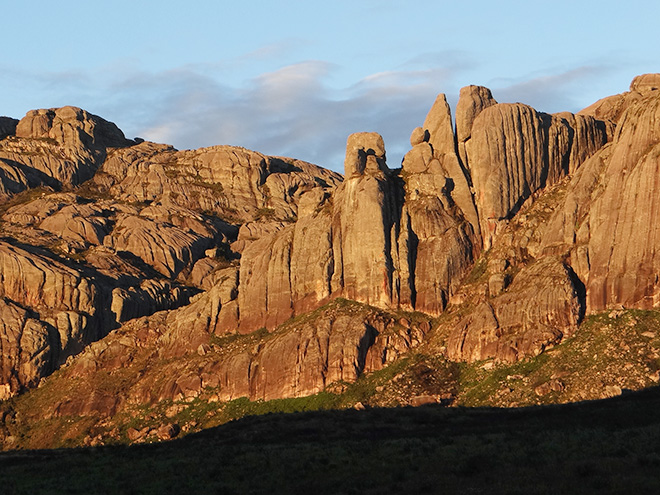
[0,242,103,398]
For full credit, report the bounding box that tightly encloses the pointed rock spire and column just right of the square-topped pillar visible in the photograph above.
[399,122,479,314]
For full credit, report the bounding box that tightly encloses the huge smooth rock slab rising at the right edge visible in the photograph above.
[545,83,660,311]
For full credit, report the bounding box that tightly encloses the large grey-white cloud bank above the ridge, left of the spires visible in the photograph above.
[91,61,464,170]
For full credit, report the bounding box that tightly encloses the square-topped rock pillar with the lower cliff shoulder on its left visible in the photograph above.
[238,133,398,333]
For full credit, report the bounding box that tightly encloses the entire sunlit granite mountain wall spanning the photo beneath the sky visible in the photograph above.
[0,74,660,450]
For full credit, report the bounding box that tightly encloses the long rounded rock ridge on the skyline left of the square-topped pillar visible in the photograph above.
[102,142,341,223]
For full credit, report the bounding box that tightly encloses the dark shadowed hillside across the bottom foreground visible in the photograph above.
[0,388,660,495]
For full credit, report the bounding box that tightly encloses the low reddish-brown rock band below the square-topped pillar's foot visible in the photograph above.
[55,298,430,415]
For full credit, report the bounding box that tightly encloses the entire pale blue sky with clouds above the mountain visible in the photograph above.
[0,0,660,171]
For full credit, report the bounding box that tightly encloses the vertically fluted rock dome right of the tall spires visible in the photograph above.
[466,103,607,248]
